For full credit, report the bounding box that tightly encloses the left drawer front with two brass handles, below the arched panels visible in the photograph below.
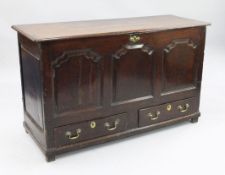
[54,113,127,146]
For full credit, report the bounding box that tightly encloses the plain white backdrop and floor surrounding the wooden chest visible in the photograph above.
[0,0,225,175]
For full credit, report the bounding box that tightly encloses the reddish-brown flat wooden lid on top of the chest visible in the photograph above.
[12,15,209,42]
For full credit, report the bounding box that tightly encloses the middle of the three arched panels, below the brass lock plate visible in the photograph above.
[112,44,154,103]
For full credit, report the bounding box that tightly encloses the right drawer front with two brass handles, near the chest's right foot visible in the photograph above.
[139,97,198,127]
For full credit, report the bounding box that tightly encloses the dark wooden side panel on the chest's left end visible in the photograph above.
[19,36,44,129]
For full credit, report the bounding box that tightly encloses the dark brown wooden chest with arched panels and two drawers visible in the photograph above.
[13,15,208,161]
